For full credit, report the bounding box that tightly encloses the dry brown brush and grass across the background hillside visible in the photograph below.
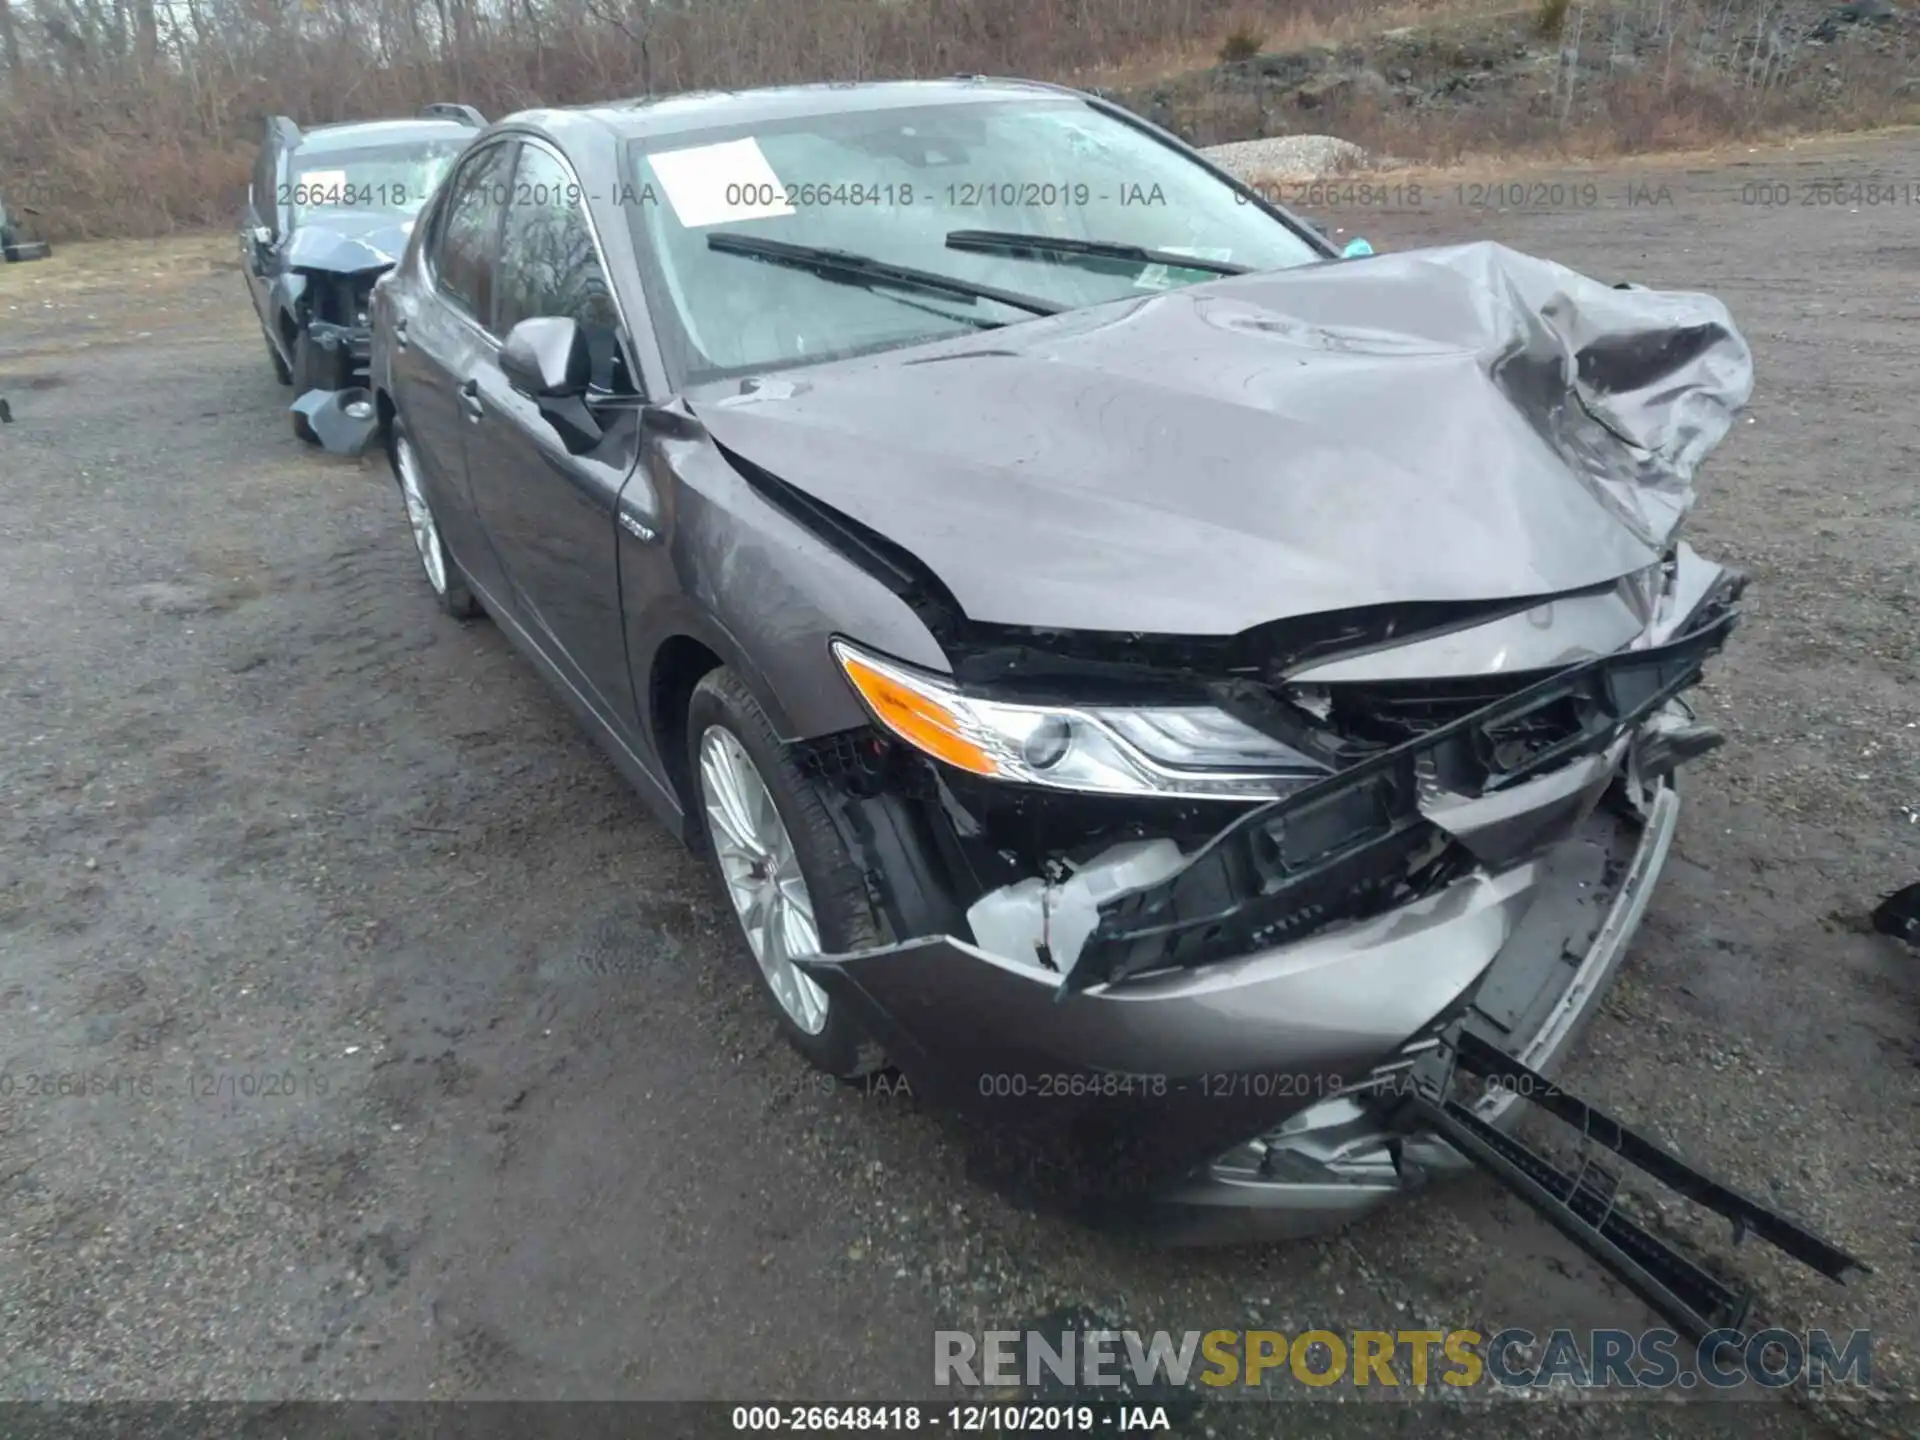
[0,0,1920,240]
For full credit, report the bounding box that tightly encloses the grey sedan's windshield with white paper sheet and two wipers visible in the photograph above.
[620,96,1323,386]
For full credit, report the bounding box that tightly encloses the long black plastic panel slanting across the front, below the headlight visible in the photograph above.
[1062,595,1741,995]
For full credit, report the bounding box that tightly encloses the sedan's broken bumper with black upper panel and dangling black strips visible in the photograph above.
[799,557,1864,1340]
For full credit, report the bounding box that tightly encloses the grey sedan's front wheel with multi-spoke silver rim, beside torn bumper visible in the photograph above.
[687,666,887,1079]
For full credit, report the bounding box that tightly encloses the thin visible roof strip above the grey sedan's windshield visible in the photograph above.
[507,75,1087,138]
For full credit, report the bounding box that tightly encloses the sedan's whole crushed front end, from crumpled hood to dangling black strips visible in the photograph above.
[707,246,1853,1331]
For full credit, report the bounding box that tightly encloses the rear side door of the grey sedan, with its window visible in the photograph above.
[392,136,518,605]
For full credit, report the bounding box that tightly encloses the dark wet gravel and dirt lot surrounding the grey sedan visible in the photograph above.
[0,136,1920,1436]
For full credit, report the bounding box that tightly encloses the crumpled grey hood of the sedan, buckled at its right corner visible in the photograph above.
[687,244,1753,636]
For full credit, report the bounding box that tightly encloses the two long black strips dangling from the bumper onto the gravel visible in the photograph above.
[1402,1021,1870,1342]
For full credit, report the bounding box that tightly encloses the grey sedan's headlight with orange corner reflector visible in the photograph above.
[833,639,1327,799]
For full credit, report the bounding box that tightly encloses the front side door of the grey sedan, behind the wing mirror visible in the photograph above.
[465,138,639,737]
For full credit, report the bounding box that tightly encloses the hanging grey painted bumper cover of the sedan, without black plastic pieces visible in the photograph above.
[804,755,1680,1213]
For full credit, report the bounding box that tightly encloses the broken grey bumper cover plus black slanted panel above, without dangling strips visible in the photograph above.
[801,606,1738,1205]
